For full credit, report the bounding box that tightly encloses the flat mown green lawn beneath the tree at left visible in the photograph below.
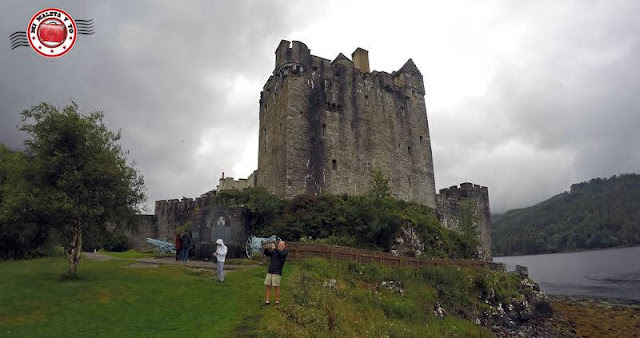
[0,257,265,337]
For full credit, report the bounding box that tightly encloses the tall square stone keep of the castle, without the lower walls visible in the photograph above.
[255,40,436,209]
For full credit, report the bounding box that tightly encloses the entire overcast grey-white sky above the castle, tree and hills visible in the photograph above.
[0,0,640,213]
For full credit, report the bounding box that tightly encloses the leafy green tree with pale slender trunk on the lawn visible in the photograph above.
[3,102,145,275]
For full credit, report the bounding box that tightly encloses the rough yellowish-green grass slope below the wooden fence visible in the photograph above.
[264,259,510,337]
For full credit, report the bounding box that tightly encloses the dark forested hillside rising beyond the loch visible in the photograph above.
[492,174,640,256]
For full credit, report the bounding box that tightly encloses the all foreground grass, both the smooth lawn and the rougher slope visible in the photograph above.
[0,258,518,337]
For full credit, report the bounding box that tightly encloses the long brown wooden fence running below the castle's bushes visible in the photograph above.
[286,242,487,268]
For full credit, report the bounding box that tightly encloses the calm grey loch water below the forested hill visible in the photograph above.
[493,246,640,301]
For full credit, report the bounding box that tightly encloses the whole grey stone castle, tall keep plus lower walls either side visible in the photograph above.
[139,40,491,261]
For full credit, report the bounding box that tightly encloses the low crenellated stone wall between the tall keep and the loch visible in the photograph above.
[436,182,493,261]
